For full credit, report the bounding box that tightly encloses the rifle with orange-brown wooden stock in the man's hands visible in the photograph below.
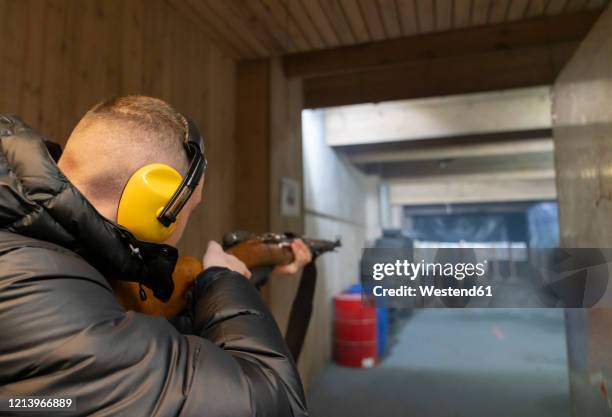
[111,231,341,318]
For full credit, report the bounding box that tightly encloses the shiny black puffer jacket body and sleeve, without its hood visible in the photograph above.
[0,247,307,417]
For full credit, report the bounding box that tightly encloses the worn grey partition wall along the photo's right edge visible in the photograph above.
[553,7,612,417]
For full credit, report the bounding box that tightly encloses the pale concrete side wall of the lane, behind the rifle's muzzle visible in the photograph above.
[300,110,378,384]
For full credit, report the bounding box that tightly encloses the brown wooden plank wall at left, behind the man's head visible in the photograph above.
[0,0,235,256]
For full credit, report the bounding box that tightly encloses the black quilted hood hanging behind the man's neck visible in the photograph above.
[0,115,178,299]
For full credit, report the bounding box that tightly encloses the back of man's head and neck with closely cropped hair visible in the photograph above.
[59,95,189,218]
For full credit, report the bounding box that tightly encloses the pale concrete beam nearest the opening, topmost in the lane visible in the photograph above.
[323,86,552,146]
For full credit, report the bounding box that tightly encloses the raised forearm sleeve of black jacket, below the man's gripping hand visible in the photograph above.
[179,268,307,417]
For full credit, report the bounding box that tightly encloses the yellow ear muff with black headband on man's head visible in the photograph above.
[117,118,206,242]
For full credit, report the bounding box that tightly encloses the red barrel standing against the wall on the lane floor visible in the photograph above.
[334,294,378,368]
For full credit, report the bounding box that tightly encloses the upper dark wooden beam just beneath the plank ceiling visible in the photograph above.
[283,11,600,78]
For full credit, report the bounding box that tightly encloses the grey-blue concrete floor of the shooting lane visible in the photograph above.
[309,309,569,417]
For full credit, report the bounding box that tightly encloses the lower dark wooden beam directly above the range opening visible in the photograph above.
[304,41,579,108]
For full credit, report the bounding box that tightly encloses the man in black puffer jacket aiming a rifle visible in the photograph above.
[0,96,310,417]
